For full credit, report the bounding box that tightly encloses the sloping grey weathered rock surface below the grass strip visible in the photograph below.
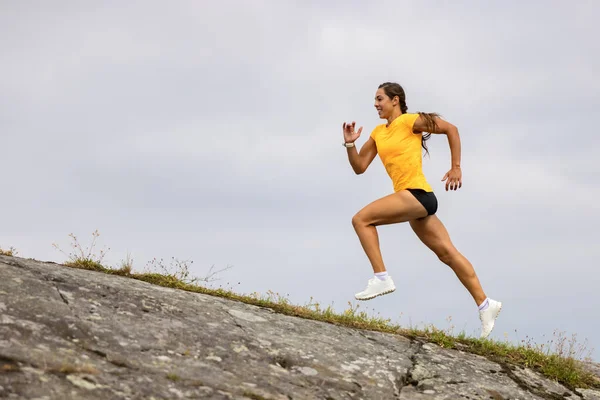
[0,256,600,400]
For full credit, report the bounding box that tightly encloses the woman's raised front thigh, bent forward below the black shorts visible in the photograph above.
[352,190,427,226]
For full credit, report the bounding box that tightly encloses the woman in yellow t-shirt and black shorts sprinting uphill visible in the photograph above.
[343,82,502,338]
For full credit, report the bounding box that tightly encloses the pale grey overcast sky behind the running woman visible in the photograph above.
[0,0,600,359]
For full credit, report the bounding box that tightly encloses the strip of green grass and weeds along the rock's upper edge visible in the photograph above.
[7,231,600,390]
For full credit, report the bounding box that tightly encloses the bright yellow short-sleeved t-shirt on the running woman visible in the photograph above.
[371,114,433,192]
